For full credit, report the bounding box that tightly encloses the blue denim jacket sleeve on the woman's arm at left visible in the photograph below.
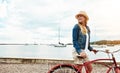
[72,26,81,54]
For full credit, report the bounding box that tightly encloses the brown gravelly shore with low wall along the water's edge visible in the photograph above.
[0,58,116,73]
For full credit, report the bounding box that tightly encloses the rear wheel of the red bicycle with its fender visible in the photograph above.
[48,64,79,73]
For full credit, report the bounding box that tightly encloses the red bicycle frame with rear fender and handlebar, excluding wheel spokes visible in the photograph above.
[48,49,120,73]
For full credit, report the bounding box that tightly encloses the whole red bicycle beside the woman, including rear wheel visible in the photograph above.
[48,49,120,73]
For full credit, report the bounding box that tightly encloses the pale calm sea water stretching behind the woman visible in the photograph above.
[0,45,120,62]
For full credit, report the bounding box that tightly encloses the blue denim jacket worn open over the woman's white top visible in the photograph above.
[72,24,93,54]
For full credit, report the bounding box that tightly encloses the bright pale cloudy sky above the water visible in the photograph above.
[0,0,120,43]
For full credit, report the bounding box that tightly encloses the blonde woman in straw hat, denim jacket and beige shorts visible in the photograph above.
[72,11,97,73]
